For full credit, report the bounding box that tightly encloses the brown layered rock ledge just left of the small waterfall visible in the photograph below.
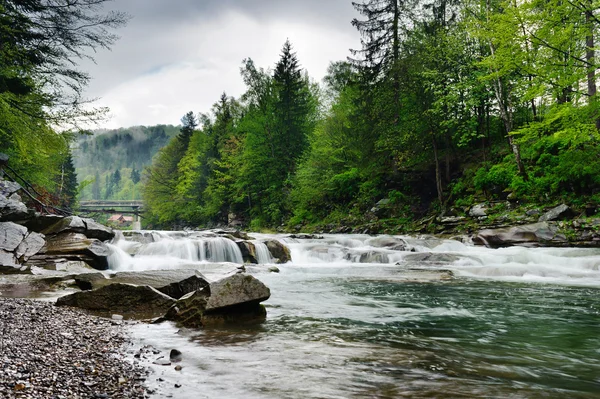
[40,233,110,270]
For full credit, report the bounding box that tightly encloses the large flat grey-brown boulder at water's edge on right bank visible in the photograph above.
[473,222,569,248]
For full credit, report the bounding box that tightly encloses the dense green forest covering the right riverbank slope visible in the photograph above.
[144,0,600,229]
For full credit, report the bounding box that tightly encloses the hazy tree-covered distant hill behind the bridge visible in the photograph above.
[73,125,179,200]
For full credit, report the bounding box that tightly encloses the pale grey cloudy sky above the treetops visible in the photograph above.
[82,0,360,128]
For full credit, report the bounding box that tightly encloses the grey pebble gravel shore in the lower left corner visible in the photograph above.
[0,298,148,399]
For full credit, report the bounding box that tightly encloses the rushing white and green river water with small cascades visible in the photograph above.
[111,233,600,398]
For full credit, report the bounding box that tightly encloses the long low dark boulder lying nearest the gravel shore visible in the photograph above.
[56,283,175,318]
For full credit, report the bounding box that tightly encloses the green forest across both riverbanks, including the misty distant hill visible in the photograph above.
[0,0,600,232]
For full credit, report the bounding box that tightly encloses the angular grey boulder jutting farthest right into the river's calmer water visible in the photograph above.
[206,274,271,311]
